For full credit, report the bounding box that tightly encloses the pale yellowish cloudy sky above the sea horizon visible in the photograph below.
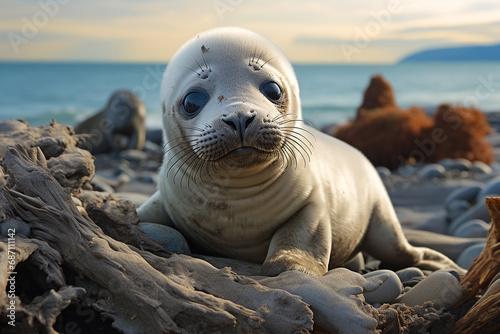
[0,0,500,64]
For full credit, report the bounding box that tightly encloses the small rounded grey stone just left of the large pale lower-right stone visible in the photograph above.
[363,270,403,305]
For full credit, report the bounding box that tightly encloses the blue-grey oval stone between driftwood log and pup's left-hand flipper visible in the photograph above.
[139,222,191,254]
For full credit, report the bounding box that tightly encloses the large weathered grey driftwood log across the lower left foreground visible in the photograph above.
[1,147,312,333]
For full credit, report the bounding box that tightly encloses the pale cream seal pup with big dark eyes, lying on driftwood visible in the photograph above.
[138,28,461,276]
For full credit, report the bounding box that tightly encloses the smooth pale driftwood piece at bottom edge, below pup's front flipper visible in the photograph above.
[258,268,383,333]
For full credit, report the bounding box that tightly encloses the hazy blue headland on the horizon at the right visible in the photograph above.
[400,44,500,63]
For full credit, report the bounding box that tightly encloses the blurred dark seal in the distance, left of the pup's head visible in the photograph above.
[75,90,146,154]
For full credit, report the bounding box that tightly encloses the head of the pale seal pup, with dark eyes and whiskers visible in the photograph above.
[161,28,311,185]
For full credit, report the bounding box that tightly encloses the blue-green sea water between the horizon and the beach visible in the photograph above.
[0,62,500,128]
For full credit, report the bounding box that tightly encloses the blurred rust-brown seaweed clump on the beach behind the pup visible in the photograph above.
[332,77,493,169]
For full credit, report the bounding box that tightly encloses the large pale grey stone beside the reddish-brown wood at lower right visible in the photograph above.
[397,269,465,309]
